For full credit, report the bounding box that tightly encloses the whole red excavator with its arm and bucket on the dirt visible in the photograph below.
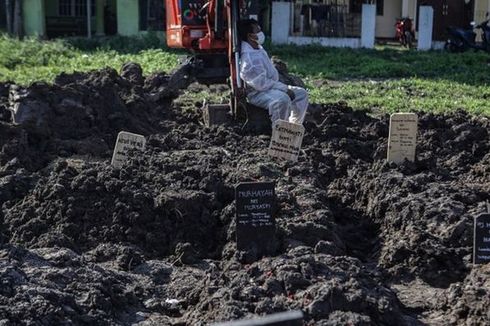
[166,0,268,128]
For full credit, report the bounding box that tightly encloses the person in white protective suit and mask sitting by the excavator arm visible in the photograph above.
[238,19,308,124]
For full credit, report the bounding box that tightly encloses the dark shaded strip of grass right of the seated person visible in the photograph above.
[270,46,490,85]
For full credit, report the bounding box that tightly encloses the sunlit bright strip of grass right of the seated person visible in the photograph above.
[307,78,490,116]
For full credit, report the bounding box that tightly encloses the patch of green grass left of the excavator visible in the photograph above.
[0,33,182,85]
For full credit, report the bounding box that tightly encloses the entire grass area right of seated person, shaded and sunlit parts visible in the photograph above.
[270,46,490,116]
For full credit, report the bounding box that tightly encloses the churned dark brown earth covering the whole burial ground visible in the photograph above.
[0,65,490,325]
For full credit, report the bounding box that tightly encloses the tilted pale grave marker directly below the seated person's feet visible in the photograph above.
[269,120,305,162]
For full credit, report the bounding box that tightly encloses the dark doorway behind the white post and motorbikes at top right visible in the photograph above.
[417,0,475,41]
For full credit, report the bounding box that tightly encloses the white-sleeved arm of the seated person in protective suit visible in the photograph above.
[240,53,288,93]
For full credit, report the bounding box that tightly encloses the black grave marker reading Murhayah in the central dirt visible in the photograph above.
[235,182,276,256]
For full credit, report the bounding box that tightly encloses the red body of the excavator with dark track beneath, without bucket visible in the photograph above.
[166,0,241,88]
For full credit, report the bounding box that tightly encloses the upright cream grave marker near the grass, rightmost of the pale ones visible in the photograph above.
[388,113,418,164]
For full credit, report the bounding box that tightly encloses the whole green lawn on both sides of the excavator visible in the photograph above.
[0,34,490,116]
